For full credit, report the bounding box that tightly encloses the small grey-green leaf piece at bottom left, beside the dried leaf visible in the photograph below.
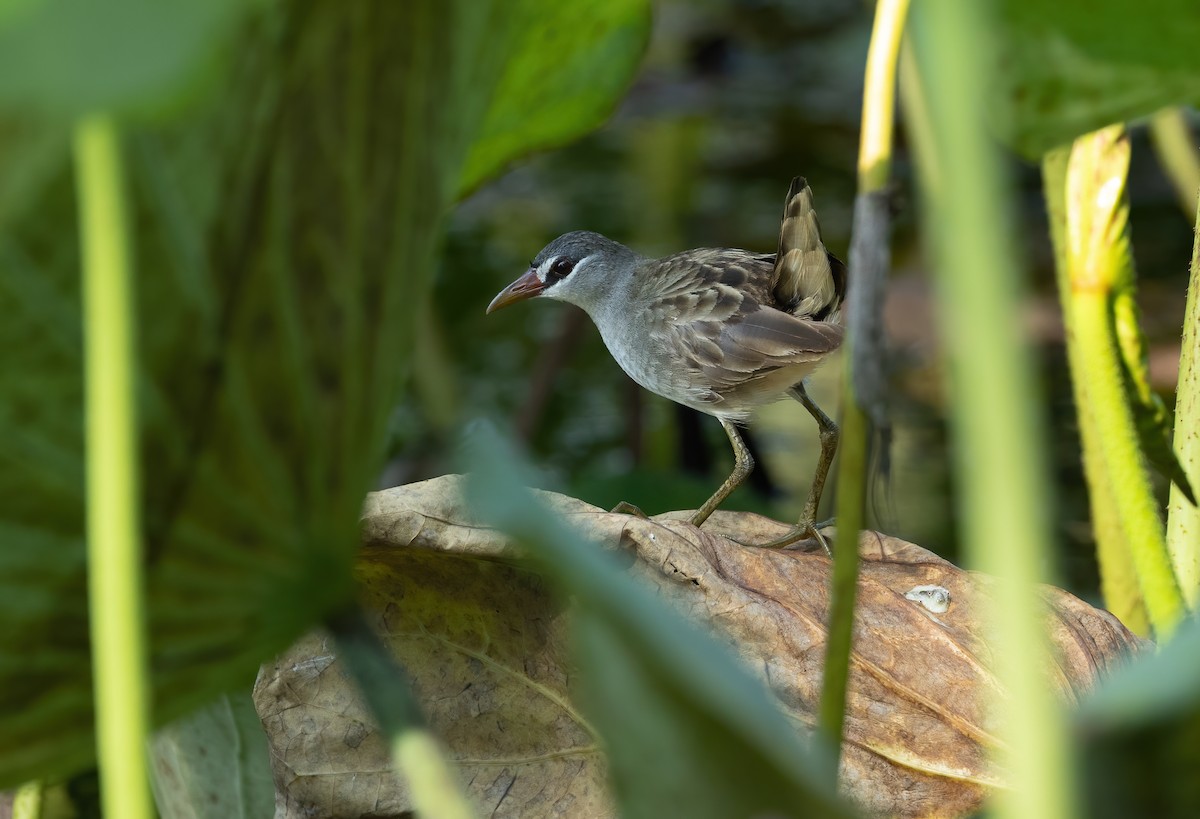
[150,691,275,819]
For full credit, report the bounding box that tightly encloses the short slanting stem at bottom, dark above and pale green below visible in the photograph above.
[326,608,475,819]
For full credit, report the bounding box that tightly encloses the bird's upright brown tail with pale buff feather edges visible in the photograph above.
[772,177,846,321]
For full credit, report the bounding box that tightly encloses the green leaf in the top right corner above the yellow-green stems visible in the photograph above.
[989,0,1200,160]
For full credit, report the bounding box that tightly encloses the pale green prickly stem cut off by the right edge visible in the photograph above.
[1166,200,1200,609]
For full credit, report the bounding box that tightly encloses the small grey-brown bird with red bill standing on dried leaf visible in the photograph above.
[487,177,847,550]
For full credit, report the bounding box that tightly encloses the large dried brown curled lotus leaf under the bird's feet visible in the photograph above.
[256,476,1144,817]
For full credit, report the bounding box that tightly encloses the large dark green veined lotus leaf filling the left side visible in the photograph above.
[0,0,644,787]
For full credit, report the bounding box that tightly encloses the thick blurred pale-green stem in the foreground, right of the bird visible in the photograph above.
[912,0,1078,819]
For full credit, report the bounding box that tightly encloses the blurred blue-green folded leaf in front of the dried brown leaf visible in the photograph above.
[460,434,853,819]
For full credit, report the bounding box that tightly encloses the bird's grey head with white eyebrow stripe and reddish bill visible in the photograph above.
[487,231,638,312]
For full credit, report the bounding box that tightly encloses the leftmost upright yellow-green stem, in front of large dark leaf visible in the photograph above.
[74,115,154,819]
